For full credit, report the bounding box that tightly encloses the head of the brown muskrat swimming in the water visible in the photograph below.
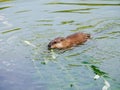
[48,37,65,49]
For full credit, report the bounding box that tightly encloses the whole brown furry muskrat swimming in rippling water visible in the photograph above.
[48,32,90,49]
